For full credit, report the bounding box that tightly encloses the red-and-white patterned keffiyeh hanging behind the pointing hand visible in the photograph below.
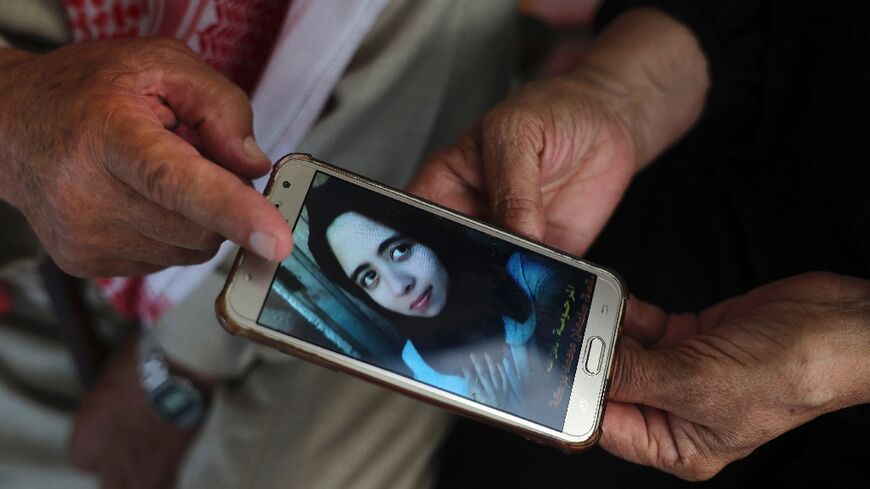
[65,0,386,324]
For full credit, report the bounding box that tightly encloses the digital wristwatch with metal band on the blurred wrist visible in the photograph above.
[138,331,208,429]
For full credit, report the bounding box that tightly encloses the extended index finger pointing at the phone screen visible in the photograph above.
[107,118,292,261]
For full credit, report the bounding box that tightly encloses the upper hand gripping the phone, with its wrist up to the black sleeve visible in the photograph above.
[408,9,709,255]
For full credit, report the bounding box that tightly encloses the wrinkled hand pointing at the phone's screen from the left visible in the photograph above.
[0,39,291,276]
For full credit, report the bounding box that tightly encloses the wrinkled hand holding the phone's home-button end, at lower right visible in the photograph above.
[601,273,870,479]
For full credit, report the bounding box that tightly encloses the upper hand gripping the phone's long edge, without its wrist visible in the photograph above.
[408,75,635,254]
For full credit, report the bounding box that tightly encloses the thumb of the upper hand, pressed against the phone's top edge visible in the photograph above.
[482,115,547,240]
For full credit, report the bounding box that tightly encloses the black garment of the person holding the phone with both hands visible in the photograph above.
[441,0,870,488]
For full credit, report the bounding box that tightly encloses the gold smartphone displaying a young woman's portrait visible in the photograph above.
[217,154,627,451]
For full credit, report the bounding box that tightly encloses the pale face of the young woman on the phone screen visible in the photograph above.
[326,212,449,318]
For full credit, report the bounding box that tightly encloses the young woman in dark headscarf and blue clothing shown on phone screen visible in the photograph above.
[306,179,587,424]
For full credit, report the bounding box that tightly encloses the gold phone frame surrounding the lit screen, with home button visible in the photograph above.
[217,154,627,450]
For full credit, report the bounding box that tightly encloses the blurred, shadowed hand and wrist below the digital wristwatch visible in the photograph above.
[69,342,204,489]
